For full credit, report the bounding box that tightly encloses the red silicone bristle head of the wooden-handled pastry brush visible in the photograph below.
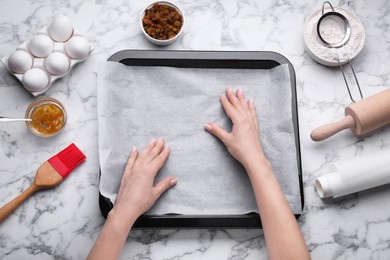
[48,144,86,178]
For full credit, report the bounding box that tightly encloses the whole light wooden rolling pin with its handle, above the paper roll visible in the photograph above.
[310,89,390,142]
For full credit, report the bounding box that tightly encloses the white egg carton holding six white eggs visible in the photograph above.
[1,15,94,96]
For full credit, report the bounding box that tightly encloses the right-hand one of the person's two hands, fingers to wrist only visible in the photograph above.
[205,87,268,168]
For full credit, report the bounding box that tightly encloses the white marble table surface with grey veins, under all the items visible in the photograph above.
[0,0,390,260]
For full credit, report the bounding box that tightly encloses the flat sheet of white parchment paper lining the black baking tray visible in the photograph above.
[97,62,301,215]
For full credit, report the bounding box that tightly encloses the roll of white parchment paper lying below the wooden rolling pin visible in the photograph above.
[315,151,390,198]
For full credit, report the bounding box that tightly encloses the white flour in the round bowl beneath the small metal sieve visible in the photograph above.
[304,7,365,66]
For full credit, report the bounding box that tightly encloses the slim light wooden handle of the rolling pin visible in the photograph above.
[310,115,355,142]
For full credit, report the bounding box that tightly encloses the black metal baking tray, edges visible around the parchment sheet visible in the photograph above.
[99,50,304,229]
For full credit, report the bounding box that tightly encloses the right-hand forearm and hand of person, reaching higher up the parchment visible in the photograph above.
[205,88,310,259]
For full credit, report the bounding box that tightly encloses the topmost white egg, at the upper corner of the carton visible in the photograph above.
[49,15,73,42]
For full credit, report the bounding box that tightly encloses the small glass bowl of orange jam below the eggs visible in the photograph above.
[25,98,66,137]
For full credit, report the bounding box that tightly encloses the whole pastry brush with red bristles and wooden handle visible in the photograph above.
[0,144,86,223]
